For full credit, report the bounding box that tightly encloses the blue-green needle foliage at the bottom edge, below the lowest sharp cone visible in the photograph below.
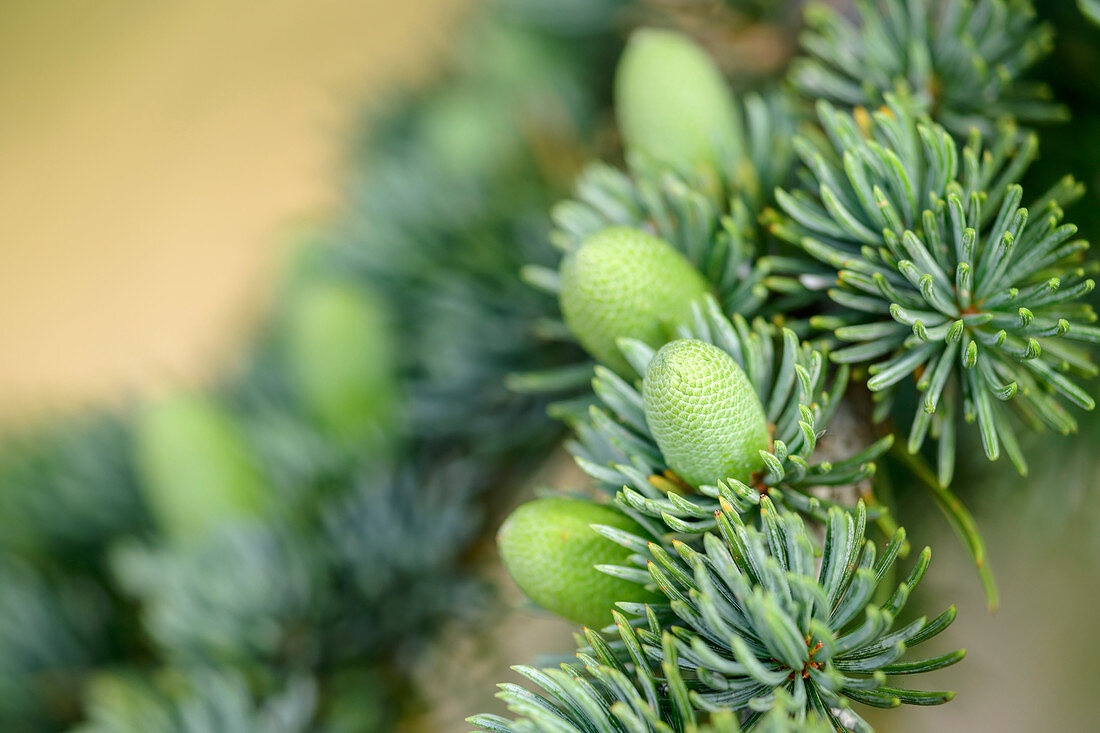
[470,497,965,733]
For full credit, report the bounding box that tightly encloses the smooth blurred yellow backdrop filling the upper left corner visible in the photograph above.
[0,0,466,422]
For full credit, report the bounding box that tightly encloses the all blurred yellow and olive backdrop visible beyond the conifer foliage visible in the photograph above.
[0,0,1100,732]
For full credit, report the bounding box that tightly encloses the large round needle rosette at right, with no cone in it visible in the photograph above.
[773,96,1100,485]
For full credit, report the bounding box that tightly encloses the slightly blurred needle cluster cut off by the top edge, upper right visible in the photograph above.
[791,0,1066,138]
